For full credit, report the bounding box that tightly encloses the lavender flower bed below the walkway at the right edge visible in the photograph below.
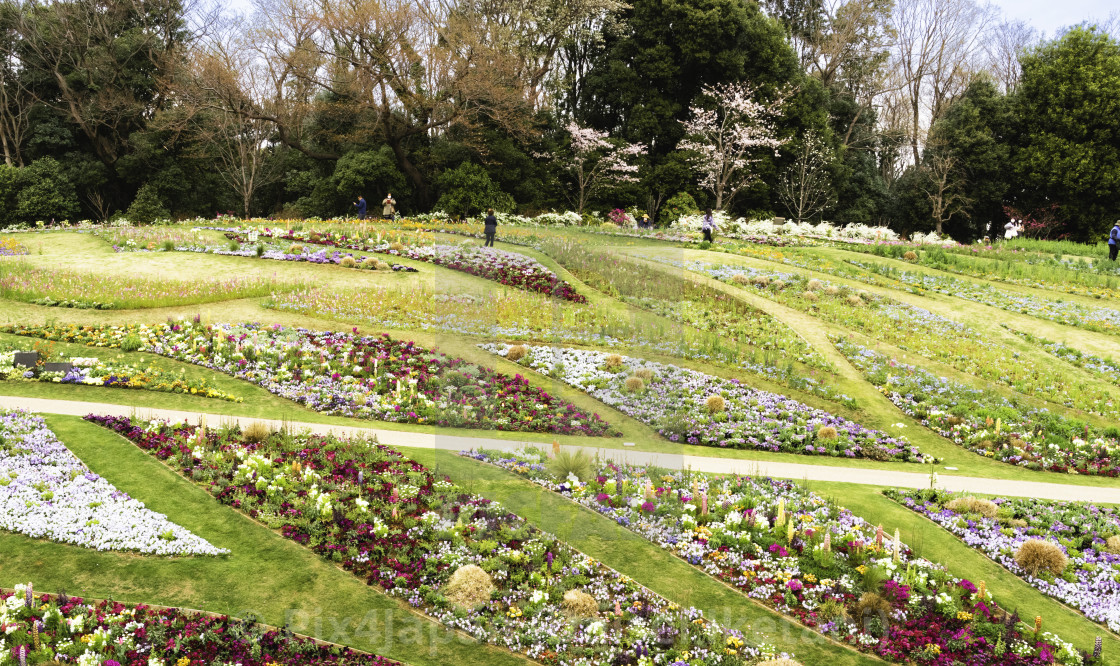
[884,490,1120,631]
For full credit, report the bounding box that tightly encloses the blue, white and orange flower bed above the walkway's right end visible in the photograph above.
[832,337,1120,477]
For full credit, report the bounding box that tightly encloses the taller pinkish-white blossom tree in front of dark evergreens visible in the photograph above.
[678,83,786,209]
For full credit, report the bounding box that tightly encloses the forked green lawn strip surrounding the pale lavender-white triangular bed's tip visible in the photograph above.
[0,416,526,666]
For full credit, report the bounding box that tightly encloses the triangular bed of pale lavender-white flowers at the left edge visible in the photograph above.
[0,411,230,555]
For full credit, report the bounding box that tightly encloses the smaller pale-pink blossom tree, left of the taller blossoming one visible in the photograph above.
[561,122,646,215]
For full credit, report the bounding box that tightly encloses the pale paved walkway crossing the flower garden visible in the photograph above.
[0,396,1120,504]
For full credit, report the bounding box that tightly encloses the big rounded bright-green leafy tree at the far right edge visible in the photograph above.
[1011,27,1120,241]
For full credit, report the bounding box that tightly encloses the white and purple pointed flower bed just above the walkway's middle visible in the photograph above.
[482,345,923,461]
